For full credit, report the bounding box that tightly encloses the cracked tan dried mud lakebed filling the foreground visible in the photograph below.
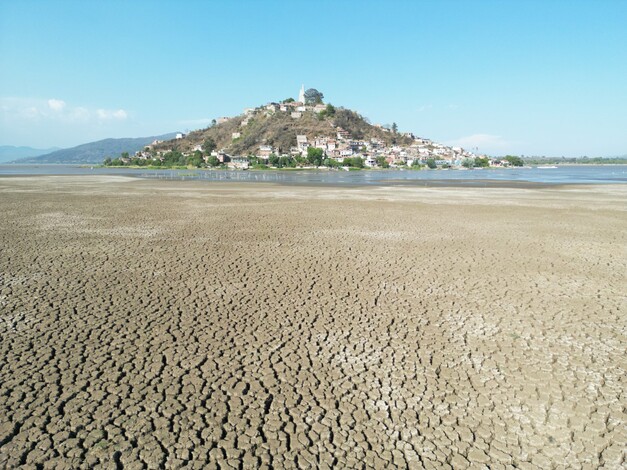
[0,177,627,469]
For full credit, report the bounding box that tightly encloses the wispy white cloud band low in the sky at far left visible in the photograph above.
[0,97,128,122]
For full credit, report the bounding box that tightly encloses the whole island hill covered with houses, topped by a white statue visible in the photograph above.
[105,86,522,169]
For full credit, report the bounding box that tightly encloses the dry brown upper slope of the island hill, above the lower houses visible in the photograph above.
[155,105,412,155]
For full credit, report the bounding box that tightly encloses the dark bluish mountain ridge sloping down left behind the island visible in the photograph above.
[5,133,176,164]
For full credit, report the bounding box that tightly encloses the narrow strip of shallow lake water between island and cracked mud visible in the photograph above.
[0,165,627,186]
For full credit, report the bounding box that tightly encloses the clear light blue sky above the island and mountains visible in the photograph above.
[0,0,627,156]
